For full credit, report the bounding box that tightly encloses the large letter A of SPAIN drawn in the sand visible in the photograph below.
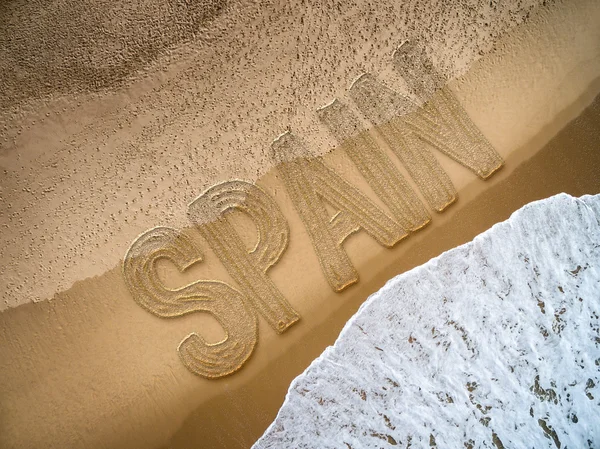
[271,132,408,292]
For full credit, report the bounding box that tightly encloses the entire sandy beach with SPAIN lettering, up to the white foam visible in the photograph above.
[0,0,600,449]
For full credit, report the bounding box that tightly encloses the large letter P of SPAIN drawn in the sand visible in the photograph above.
[188,181,300,333]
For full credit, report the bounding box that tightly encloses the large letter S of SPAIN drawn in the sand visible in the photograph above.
[123,227,258,379]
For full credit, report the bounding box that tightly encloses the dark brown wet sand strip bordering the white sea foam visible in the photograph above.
[164,86,600,448]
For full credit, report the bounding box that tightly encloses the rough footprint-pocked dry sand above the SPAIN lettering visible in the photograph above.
[0,1,584,308]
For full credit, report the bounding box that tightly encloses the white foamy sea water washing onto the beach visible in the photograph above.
[254,194,600,449]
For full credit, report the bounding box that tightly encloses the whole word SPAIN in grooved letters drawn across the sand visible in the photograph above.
[123,42,503,379]
